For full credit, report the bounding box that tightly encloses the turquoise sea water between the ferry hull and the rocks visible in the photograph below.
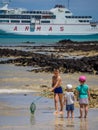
[0,34,98,46]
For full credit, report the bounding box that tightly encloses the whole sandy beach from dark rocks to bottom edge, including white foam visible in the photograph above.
[0,64,98,130]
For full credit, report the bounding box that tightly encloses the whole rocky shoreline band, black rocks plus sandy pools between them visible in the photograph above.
[0,40,98,74]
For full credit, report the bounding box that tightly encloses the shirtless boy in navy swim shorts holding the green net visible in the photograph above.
[50,69,63,114]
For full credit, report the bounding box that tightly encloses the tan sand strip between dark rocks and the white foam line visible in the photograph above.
[0,64,98,92]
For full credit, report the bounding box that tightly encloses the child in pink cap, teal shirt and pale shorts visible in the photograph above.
[76,76,90,118]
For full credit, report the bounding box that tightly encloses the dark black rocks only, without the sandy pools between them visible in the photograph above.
[0,40,98,74]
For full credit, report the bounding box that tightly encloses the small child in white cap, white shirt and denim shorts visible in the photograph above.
[64,84,75,118]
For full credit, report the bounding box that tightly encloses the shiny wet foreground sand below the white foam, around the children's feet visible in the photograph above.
[0,93,98,130]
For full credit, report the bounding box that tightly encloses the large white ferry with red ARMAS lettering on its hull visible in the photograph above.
[0,3,98,36]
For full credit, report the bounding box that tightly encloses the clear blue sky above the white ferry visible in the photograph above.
[0,0,98,21]
